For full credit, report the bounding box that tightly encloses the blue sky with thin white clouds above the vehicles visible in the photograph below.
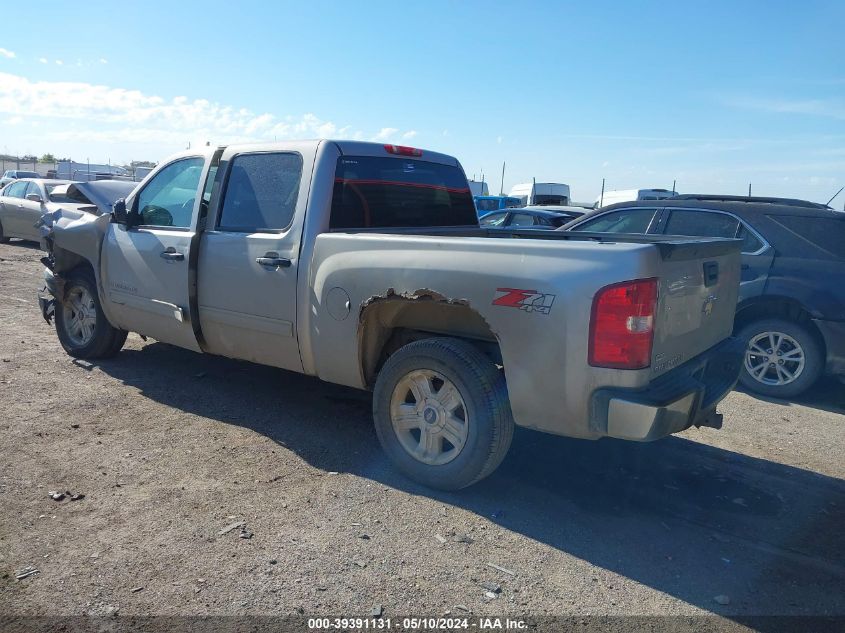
[0,0,845,204]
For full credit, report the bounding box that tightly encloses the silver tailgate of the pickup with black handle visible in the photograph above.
[651,239,741,377]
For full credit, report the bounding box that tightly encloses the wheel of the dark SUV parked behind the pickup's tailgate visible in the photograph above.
[737,319,824,398]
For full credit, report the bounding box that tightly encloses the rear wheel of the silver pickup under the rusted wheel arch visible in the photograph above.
[373,338,514,490]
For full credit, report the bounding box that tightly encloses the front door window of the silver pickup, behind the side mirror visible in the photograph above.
[136,157,205,228]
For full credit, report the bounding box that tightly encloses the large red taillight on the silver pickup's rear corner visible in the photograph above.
[589,279,657,369]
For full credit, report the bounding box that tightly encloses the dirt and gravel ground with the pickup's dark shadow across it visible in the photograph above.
[0,241,845,618]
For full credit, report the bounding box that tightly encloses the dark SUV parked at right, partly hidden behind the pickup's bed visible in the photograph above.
[562,195,845,398]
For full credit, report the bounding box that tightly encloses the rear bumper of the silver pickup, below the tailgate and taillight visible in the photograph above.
[592,337,744,442]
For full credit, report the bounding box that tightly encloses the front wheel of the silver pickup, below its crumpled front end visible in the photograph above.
[55,268,127,359]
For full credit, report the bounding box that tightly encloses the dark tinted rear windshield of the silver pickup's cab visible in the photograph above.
[331,156,478,229]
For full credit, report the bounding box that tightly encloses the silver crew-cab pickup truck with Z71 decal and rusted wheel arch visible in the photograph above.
[41,140,742,489]
